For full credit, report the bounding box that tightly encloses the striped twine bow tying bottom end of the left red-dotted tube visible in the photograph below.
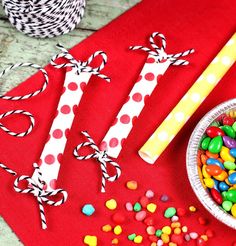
[0,163,68,229]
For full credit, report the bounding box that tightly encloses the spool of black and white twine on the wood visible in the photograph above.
[2,0,85,38]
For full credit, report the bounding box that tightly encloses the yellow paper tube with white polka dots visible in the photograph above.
[138,33,236,164]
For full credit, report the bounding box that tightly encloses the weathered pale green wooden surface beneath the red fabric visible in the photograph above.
[0,0,140,246]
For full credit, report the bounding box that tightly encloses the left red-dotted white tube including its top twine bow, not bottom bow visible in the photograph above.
[33,46,108,190]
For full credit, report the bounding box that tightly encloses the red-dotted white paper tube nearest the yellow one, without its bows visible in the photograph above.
[100,55,171,158]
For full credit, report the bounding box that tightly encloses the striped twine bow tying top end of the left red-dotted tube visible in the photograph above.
[51,44,110,82]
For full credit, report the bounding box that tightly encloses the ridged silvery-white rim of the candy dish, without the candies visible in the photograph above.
[186,99,236,229]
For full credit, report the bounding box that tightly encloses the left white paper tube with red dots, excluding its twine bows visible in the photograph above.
[32,68,92,191]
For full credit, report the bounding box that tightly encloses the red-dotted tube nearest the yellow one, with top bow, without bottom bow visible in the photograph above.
[100,32,194,158]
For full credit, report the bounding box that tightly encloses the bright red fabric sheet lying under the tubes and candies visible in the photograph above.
[0,0,236,246]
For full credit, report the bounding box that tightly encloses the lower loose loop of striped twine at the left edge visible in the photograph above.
[0,110,35,137]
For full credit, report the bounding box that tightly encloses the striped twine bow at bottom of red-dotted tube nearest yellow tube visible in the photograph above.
[74,131,121,193]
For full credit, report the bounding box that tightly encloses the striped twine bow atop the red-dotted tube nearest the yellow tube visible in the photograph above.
[130,32,194,66]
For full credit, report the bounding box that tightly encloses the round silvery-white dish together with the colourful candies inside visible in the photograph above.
[186,99,236,229]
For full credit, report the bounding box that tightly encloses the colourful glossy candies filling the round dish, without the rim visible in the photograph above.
[197,114,236,218]
